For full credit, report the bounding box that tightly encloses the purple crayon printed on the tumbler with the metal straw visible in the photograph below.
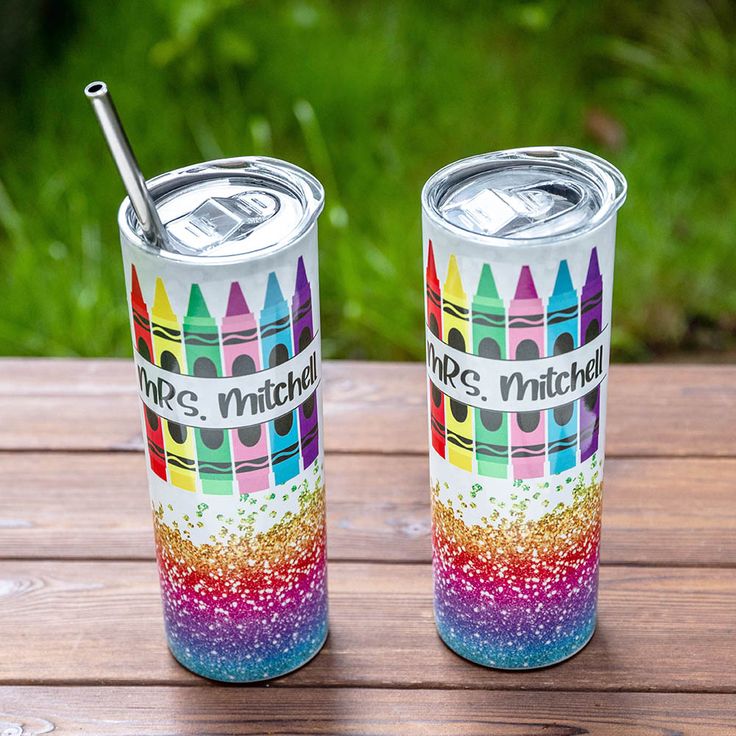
[291,257,319,470]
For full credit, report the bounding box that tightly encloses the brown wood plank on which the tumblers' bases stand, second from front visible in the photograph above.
[0,562,736,693]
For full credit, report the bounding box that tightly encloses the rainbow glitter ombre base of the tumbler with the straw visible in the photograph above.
[154,480,327,682]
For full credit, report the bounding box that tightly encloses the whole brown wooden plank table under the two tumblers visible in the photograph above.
[0,359,736,736]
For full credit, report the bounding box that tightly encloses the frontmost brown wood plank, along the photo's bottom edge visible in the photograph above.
[0,686,736,736]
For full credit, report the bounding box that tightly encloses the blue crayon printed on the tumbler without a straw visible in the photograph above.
[547,261,579,475]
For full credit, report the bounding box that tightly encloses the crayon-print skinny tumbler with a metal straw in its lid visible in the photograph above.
[119,157,327,682]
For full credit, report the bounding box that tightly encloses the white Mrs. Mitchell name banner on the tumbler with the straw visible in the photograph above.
[133,335,322,429]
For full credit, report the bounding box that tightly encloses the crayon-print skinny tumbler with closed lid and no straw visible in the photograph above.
[422,148,626,669]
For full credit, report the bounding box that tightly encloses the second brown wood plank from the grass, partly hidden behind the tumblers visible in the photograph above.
[0,453,736,565]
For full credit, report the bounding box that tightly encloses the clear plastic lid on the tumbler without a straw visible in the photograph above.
[422,148,626,242]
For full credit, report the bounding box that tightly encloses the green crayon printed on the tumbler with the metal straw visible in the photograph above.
[182,284,233,496]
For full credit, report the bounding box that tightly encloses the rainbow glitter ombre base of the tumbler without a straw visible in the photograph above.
[432,474,601,669]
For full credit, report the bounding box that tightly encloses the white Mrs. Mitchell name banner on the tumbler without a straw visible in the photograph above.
[426,327,610,412]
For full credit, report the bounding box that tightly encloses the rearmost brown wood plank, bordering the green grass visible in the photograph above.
[0,358,736,456]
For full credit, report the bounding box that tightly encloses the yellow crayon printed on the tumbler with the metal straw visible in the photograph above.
[151,278,197,491]
